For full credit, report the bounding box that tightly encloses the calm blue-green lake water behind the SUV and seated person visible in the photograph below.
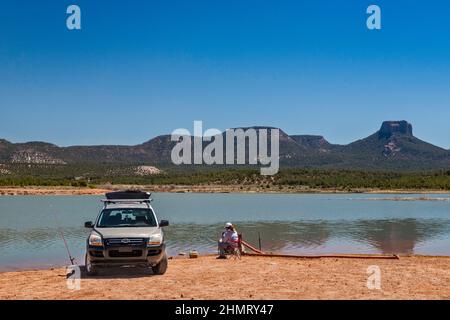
[0,193,450,271]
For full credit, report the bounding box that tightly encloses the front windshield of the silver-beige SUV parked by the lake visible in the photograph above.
[97,208,156,228]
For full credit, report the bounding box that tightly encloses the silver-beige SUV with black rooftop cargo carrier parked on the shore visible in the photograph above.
[84,190,169,275]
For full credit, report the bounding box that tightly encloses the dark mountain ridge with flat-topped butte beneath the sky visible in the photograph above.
[0,120,450,171]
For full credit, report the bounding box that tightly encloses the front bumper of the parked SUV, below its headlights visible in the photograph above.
[86,243,166,267]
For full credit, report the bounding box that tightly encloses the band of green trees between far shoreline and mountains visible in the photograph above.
[0,165,450,191]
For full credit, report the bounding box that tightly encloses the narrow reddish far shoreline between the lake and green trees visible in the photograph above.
[0,185,450,196]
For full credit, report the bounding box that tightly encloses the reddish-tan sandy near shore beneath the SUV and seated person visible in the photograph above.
[0,256,450,299]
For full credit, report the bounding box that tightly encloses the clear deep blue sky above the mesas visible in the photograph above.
[0,0,450,148]
